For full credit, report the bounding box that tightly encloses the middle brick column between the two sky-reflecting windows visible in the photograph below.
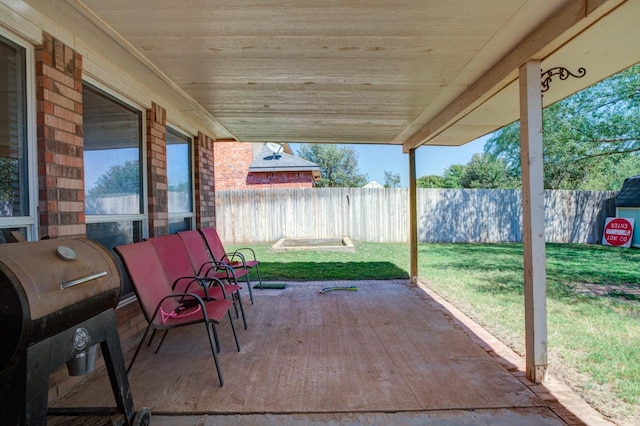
[147,103,169,237]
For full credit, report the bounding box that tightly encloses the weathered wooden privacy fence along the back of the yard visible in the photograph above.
[216,188,616,244]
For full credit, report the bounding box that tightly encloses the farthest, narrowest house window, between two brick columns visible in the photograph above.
[167,128,193,234]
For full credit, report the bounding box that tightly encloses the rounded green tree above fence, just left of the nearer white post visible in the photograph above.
[460,154,520,189]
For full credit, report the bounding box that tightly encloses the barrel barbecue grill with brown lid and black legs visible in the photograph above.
[0,238,150,425]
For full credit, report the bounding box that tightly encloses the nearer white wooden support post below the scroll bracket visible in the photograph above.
[520,60,547,383]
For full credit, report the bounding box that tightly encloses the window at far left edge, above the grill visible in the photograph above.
[0,32,35,243]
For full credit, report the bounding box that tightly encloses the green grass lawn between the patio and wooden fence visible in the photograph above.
[228,243,640,422]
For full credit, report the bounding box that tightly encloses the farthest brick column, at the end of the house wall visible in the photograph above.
[194,132,216,228]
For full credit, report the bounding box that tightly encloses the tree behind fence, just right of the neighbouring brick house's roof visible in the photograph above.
[298,144,368,187]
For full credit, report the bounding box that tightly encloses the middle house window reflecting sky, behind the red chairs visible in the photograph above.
[82,84,146,296]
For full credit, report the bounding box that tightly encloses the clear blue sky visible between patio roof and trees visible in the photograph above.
[290,136,488,187]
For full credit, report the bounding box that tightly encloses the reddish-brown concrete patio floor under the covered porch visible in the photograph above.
[48,280,611,426]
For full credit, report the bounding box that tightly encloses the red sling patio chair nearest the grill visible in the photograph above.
[115,241,240,386]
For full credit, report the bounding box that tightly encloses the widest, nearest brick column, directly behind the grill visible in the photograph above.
[35,33,86,238]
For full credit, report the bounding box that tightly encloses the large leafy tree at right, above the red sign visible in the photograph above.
[485,64,640,189]
